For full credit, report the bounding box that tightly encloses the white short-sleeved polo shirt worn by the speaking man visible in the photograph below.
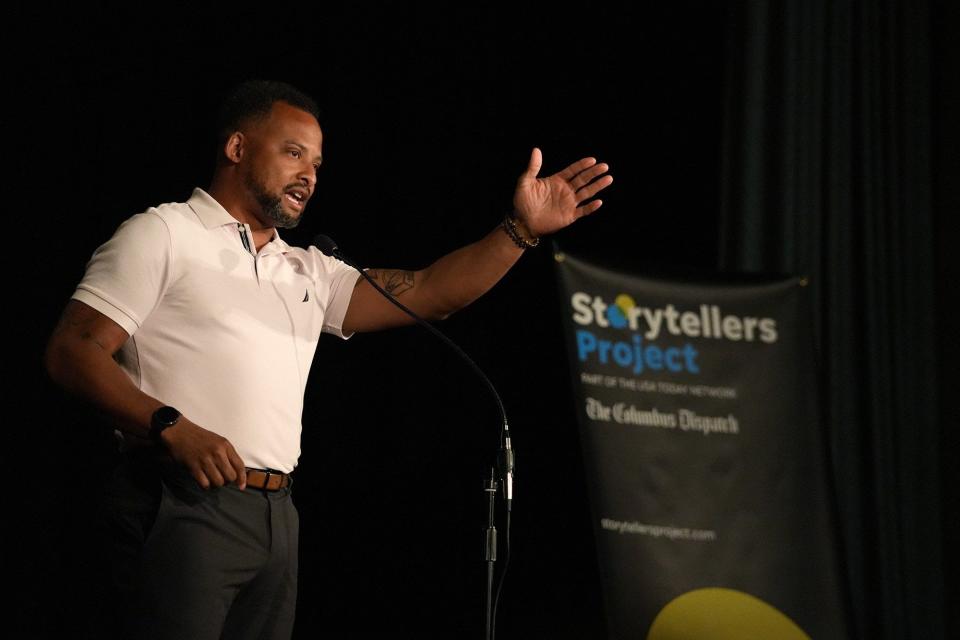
[73,189,360,472]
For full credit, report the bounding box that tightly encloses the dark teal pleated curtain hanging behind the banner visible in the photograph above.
[720,0,955,639]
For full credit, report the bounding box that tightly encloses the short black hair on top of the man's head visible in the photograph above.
[216,80,320,147]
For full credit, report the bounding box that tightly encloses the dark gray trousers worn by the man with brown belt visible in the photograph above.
[101,453,299,640]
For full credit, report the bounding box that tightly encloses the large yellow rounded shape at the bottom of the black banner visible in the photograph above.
[647,588,810,640]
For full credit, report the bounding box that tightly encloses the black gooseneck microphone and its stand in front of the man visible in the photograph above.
[313,234,514,640]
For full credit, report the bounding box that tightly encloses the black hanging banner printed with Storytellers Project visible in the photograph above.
[557,253,846,640]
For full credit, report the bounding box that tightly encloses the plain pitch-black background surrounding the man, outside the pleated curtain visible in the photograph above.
[5,0,960,638]
